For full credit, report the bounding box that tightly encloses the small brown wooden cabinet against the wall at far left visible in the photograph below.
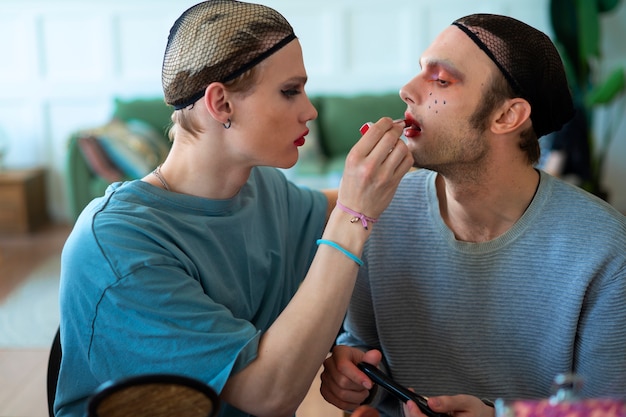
[0,168,48,234]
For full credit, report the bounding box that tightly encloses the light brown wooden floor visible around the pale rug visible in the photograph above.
[0,225,343,417]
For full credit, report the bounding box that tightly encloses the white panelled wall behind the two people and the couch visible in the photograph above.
[0,0,626,219]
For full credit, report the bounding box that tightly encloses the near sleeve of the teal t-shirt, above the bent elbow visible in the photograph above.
[90,266,260,392]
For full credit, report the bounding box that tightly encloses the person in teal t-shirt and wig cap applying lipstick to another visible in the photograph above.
[54,0,412,416]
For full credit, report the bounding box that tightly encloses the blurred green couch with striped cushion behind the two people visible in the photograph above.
[66,92,406,220]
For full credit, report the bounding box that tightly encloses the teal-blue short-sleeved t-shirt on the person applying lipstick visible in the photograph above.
[55,168,327,416]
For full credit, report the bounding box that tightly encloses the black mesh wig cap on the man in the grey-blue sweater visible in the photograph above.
[452,14,574,137]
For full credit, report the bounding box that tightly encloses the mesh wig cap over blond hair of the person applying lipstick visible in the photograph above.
[161,0,296,109]
